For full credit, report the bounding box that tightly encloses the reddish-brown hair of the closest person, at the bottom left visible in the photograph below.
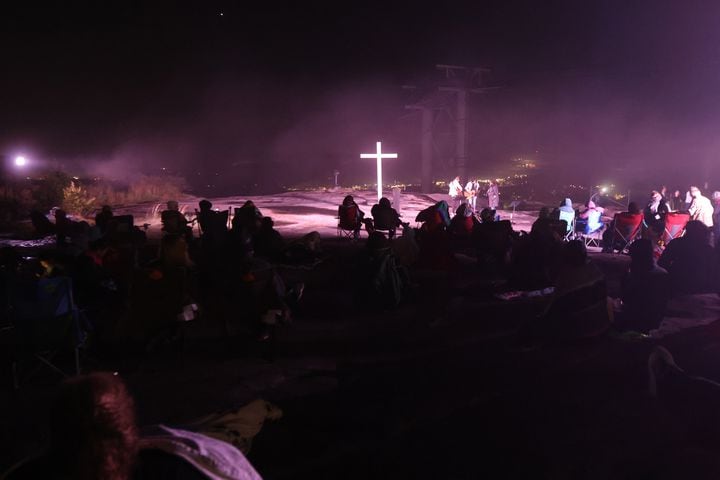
[50,373,138,480]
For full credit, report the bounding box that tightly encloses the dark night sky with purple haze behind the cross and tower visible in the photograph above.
[0,1,720,192]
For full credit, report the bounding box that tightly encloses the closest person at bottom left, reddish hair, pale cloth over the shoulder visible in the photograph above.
[3,373,260,480]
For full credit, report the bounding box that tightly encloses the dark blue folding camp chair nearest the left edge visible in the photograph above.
[11,277,84,388]
